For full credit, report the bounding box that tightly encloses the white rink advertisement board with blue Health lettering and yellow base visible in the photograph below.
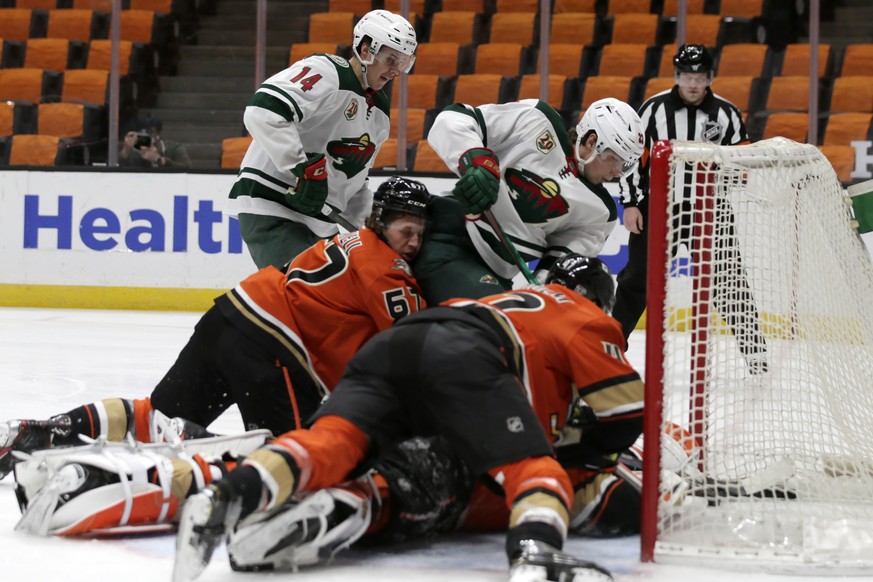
[0,170,627,311]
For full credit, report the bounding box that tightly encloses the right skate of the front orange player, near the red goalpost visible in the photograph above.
[509,540,613,582]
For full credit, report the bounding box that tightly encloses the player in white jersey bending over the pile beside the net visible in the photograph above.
[414,98,643,305]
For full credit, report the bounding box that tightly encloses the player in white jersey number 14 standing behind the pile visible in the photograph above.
[227,10,418,268]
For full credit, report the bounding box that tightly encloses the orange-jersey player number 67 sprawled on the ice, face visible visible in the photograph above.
[0,177,430,478]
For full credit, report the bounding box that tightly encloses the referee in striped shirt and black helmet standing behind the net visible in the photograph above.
[613,44,767,373]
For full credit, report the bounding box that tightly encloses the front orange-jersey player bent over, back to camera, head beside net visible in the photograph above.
[173,255,643,582]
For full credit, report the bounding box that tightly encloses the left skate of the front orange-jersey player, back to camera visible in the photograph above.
[173,482,241,582]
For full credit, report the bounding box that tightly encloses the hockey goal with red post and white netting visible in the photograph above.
[641,138,873,574]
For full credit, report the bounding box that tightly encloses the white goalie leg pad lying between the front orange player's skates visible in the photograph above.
[227,488,372,570]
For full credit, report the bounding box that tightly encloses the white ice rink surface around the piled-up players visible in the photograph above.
[0,308,873,582]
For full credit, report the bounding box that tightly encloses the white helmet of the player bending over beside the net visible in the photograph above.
[573,97,645,175]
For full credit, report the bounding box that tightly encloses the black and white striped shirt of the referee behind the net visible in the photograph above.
[620,85,749,207]
